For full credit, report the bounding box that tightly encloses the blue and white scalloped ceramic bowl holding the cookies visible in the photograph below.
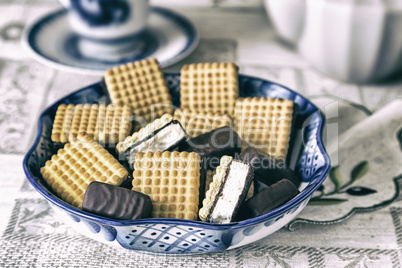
[23,74,330,254]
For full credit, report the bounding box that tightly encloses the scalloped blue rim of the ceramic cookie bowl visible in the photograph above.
[23,72,331,230]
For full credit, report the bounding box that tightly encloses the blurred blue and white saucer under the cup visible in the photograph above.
[22,7,199,75]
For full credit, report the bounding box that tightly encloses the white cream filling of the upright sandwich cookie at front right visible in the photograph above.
[210,161,250,223]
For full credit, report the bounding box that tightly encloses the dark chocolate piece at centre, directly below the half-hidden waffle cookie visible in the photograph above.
[179,127,241,170]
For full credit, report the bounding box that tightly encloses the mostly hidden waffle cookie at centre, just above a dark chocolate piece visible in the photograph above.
[174,109,232,137]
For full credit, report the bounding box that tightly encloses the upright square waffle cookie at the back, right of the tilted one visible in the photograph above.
[180,63,239,116]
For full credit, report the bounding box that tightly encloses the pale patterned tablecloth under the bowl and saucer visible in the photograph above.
[0,0,402,267]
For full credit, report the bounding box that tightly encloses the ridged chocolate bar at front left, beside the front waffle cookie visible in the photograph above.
[82,181,152,220]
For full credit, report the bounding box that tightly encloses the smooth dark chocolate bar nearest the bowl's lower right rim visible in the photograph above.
[245,179,299,217]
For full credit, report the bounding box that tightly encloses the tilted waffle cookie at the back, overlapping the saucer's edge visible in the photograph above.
[105,58,173,126]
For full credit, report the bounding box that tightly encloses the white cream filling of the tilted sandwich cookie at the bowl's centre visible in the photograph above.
[129,124,186,165]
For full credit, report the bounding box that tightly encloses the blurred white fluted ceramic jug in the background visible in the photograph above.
[265,0,402,83]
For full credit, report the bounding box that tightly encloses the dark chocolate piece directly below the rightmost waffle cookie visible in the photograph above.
[239,147,301,187]
